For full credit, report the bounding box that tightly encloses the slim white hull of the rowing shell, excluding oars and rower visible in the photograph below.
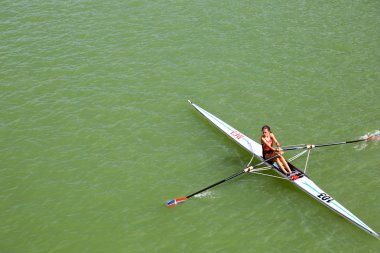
[189,100,379,239]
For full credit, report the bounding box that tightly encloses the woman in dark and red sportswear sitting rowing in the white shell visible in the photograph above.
[261,125,292,175]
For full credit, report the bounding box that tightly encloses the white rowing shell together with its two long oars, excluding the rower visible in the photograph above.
[167,100,379,239]
